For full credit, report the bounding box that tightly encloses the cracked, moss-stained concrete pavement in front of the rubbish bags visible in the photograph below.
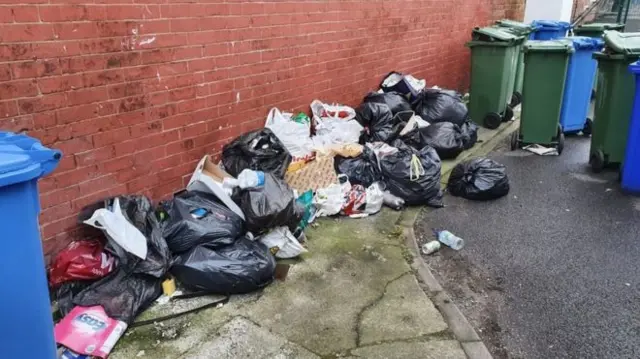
[110,210,466,359]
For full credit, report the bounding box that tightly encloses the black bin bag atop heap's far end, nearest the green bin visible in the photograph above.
[412,88,469,126]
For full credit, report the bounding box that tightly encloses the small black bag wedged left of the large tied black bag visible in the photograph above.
[333,146,382,188]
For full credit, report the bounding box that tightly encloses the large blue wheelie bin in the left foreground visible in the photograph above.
[0,131,62,359]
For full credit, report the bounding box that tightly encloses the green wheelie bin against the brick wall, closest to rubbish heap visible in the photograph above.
[467,27,524,129]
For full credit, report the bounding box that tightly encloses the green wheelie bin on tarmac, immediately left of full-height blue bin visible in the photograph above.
[511,40,574,154]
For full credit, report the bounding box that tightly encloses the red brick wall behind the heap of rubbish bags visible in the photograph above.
[0,0,524,260]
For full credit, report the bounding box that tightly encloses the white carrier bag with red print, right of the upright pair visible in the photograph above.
[311,100,363,149]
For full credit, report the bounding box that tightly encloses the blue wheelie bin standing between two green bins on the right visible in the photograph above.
[560,36,604,136]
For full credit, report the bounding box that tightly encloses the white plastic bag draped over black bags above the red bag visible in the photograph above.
[84,197,147,259]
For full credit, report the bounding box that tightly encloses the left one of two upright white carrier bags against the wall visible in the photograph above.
[264,107,313,162]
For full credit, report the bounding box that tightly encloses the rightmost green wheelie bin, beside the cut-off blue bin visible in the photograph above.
[589,31,640,172]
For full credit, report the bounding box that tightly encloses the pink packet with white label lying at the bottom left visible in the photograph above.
[55,306,127,358]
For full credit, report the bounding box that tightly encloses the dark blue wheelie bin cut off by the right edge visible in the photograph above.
[620,61,640,194]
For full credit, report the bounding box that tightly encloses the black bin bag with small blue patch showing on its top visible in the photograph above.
[162,191,244,254]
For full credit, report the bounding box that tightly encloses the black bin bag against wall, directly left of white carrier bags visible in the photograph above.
[222,128,292,178]
